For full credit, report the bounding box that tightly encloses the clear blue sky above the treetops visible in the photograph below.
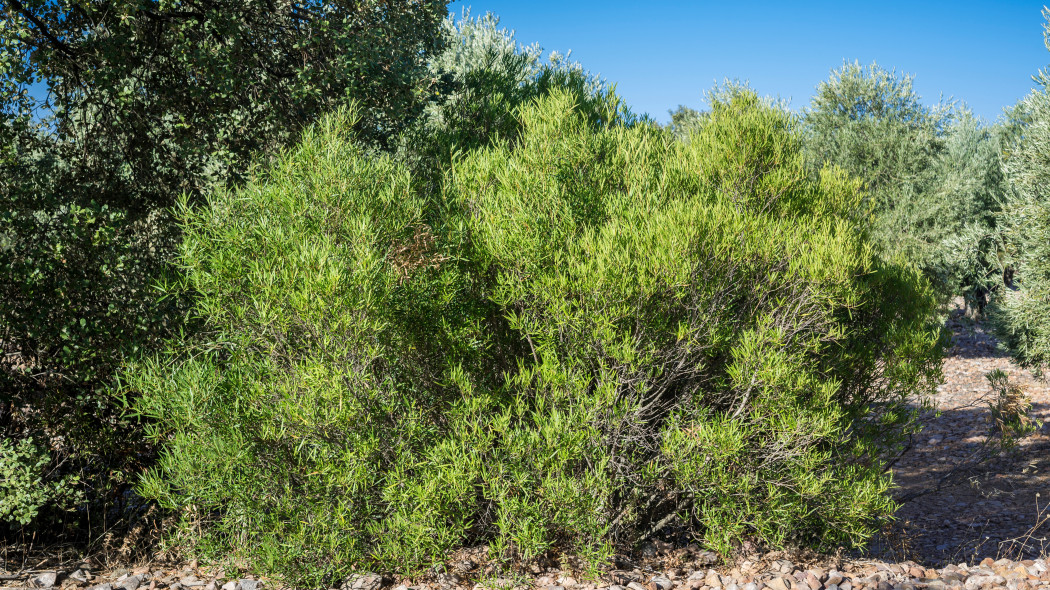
[449,0,1050,122]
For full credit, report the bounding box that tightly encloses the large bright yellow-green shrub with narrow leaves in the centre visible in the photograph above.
[125,90,940,584]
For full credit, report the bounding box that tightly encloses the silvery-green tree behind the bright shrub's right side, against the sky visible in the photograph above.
[805,63,1007,309]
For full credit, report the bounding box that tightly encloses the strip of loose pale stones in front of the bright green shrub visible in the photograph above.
[16,552,1050,590]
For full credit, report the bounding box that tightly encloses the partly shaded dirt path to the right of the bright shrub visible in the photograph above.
[874,304,1050,565]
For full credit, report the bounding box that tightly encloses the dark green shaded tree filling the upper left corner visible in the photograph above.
[0,0,446,524]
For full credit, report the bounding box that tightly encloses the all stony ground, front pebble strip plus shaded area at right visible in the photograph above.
[0,313,1050,590]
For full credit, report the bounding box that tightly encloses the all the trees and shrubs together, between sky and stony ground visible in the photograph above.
[0,0,1050,587]
